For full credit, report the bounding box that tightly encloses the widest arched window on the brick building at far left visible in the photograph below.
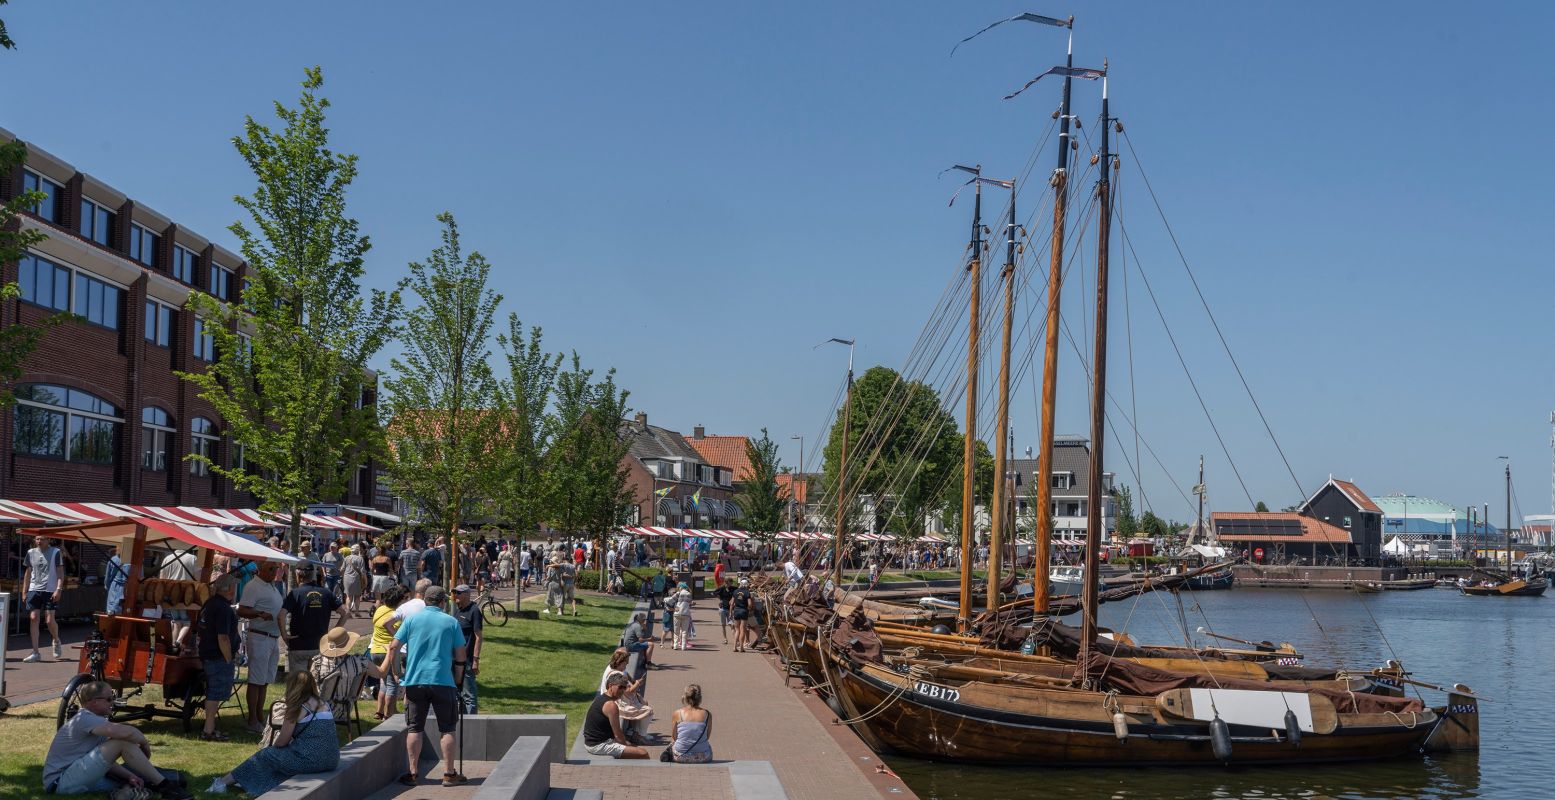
[12,383,124,464]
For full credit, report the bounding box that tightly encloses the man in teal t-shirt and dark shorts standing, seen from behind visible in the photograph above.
[386,587,468,786]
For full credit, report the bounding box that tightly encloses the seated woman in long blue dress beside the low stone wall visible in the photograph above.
[207,671,341,797]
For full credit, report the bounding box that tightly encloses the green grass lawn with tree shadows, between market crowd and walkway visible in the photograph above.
[0,595,633,800]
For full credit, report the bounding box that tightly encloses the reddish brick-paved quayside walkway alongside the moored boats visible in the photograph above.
[606,599,913,800]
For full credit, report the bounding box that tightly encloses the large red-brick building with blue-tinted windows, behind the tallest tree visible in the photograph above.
[0,129,389,507]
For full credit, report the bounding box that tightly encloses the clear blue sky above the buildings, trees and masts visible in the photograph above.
[0,0,1555,520]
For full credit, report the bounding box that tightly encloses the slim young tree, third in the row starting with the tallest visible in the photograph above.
[487,314,561,532]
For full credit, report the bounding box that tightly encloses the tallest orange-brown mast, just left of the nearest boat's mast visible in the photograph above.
[1031,17,1075,613]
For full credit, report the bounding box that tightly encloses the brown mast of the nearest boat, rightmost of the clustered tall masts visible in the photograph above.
[1079,62,1113,683]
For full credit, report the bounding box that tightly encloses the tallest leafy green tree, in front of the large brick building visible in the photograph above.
[179,67,400,545]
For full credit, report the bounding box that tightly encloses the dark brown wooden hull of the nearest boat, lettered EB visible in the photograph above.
[833,660,1437,767]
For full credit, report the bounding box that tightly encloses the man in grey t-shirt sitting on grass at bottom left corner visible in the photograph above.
[44,680,191,800]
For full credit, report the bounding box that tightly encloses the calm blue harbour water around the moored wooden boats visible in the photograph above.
[888,588,1555,800]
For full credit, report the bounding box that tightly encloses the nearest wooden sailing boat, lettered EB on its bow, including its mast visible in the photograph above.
[815,21,1477,766]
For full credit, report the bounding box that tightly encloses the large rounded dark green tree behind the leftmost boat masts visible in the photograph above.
[812,366,964,537]
